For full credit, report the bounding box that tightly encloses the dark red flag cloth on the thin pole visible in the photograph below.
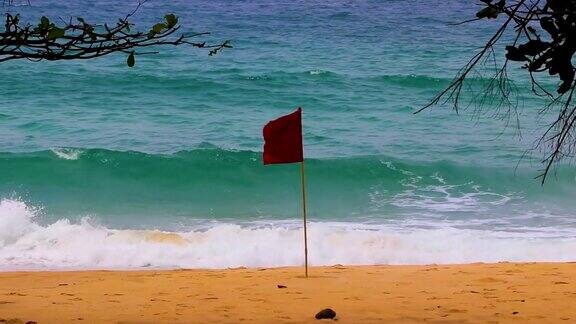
[263,107,304,164]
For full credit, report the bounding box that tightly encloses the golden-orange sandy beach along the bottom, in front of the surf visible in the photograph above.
[0,263,576,323]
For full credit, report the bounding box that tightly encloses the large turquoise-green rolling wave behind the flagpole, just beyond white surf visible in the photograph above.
[0,147,574,219]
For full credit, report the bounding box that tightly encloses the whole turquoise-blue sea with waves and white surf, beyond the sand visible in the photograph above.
[0,0,576,270]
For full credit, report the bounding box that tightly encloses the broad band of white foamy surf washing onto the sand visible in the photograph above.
[0,200,576,270]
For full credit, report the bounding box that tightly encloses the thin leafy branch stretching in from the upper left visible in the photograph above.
[0,2,232,67]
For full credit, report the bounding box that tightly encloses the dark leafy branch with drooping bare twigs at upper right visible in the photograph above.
[415,0,576,184]
